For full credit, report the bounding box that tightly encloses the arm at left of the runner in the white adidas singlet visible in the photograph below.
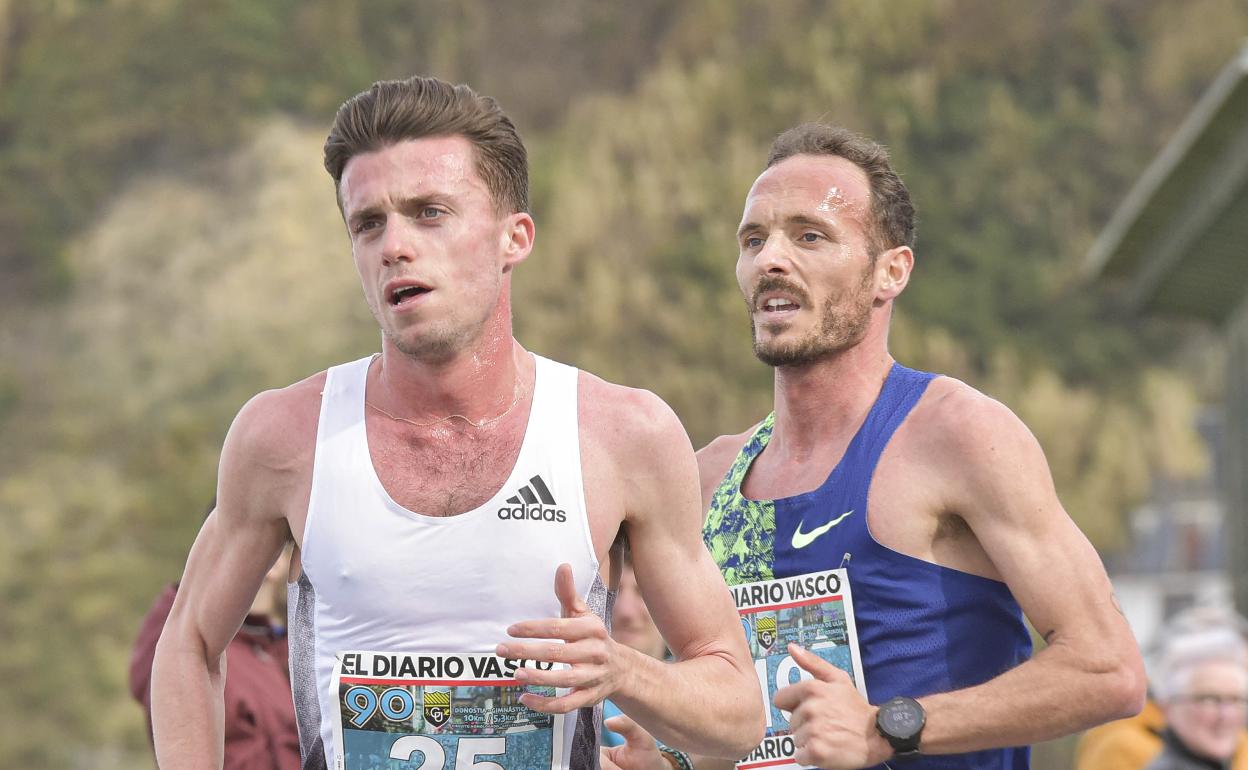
[151,393,308,769]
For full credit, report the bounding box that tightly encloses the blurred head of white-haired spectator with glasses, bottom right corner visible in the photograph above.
[1146,628,1248,770]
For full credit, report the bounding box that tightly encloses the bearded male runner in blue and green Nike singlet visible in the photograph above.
[699,124,1144,770]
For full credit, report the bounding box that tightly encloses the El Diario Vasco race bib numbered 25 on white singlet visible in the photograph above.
[332,651,565,770]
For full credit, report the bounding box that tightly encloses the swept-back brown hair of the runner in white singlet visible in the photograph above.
[324,75,529,213]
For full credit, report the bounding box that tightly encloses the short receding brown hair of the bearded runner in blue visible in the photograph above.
[766,124,915,257]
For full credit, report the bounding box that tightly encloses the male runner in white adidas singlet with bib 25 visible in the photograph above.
[152,77,763,770]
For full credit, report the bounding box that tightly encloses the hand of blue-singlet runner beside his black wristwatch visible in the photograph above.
[773,644,892,770]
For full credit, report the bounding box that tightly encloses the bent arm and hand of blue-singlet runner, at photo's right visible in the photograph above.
[774,386,1144,770]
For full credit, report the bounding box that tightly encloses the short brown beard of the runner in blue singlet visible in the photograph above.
[750,268,872,367]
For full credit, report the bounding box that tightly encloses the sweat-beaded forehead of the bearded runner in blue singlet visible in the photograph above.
[745,155,871,220]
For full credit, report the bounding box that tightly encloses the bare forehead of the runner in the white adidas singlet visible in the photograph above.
[338,136,488,211]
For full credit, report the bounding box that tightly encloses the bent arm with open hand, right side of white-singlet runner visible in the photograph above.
[497,381,764,753]
